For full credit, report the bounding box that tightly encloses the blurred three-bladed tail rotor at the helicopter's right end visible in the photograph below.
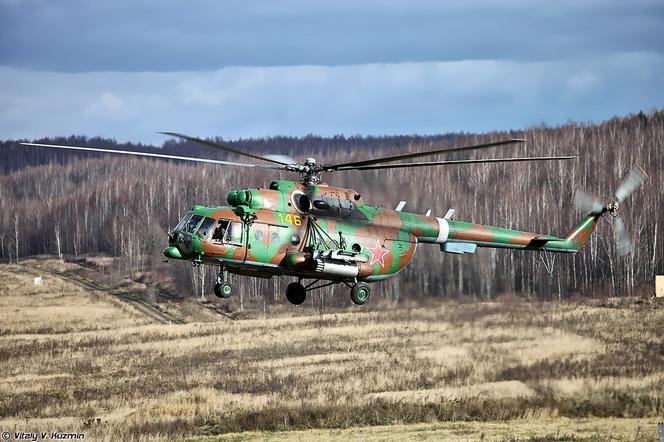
[574,165,648,256]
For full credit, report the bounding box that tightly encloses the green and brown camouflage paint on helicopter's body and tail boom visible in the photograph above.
[164,180,601,281]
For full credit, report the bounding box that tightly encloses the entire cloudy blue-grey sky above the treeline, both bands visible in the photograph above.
[0,0,664,142]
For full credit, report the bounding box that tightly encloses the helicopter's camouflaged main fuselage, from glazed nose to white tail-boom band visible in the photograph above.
[165,181,426,281]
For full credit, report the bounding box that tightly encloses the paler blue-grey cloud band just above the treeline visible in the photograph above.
[0,52,664,142]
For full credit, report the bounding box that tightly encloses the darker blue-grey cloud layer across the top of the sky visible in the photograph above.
[0,0,664,72]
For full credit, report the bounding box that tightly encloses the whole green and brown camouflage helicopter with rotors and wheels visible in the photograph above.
[21,132,646,305]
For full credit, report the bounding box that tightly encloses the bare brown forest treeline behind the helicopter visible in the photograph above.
[0,111,664,304]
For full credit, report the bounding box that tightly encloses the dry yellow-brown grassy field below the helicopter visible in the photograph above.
[0,265,664,441]
